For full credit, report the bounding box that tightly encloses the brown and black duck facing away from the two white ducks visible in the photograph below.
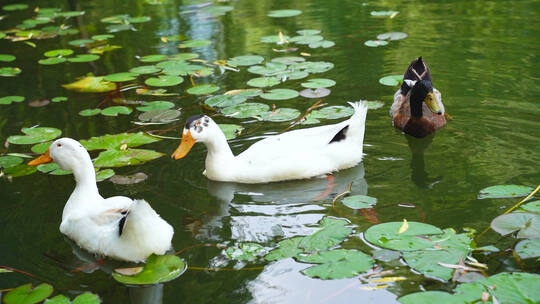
[390,56,446,138]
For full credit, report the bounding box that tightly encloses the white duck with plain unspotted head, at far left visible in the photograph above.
[28,138,174,262]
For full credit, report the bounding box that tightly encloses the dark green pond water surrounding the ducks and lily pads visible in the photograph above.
[0,0,540,303]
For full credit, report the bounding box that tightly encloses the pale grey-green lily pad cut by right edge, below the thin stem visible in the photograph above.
[491,212,540,239]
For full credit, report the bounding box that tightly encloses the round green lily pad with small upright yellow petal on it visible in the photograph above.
[364,222,443,251]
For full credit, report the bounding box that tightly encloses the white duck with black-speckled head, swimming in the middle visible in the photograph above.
[171,101,367,184]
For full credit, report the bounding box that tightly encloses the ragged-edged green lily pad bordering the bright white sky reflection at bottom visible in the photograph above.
[297,249,373,280]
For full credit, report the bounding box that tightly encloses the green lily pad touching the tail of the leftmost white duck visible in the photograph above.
[113,254,186,285]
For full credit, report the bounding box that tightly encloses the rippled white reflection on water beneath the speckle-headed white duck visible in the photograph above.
[197,163,367,243]
